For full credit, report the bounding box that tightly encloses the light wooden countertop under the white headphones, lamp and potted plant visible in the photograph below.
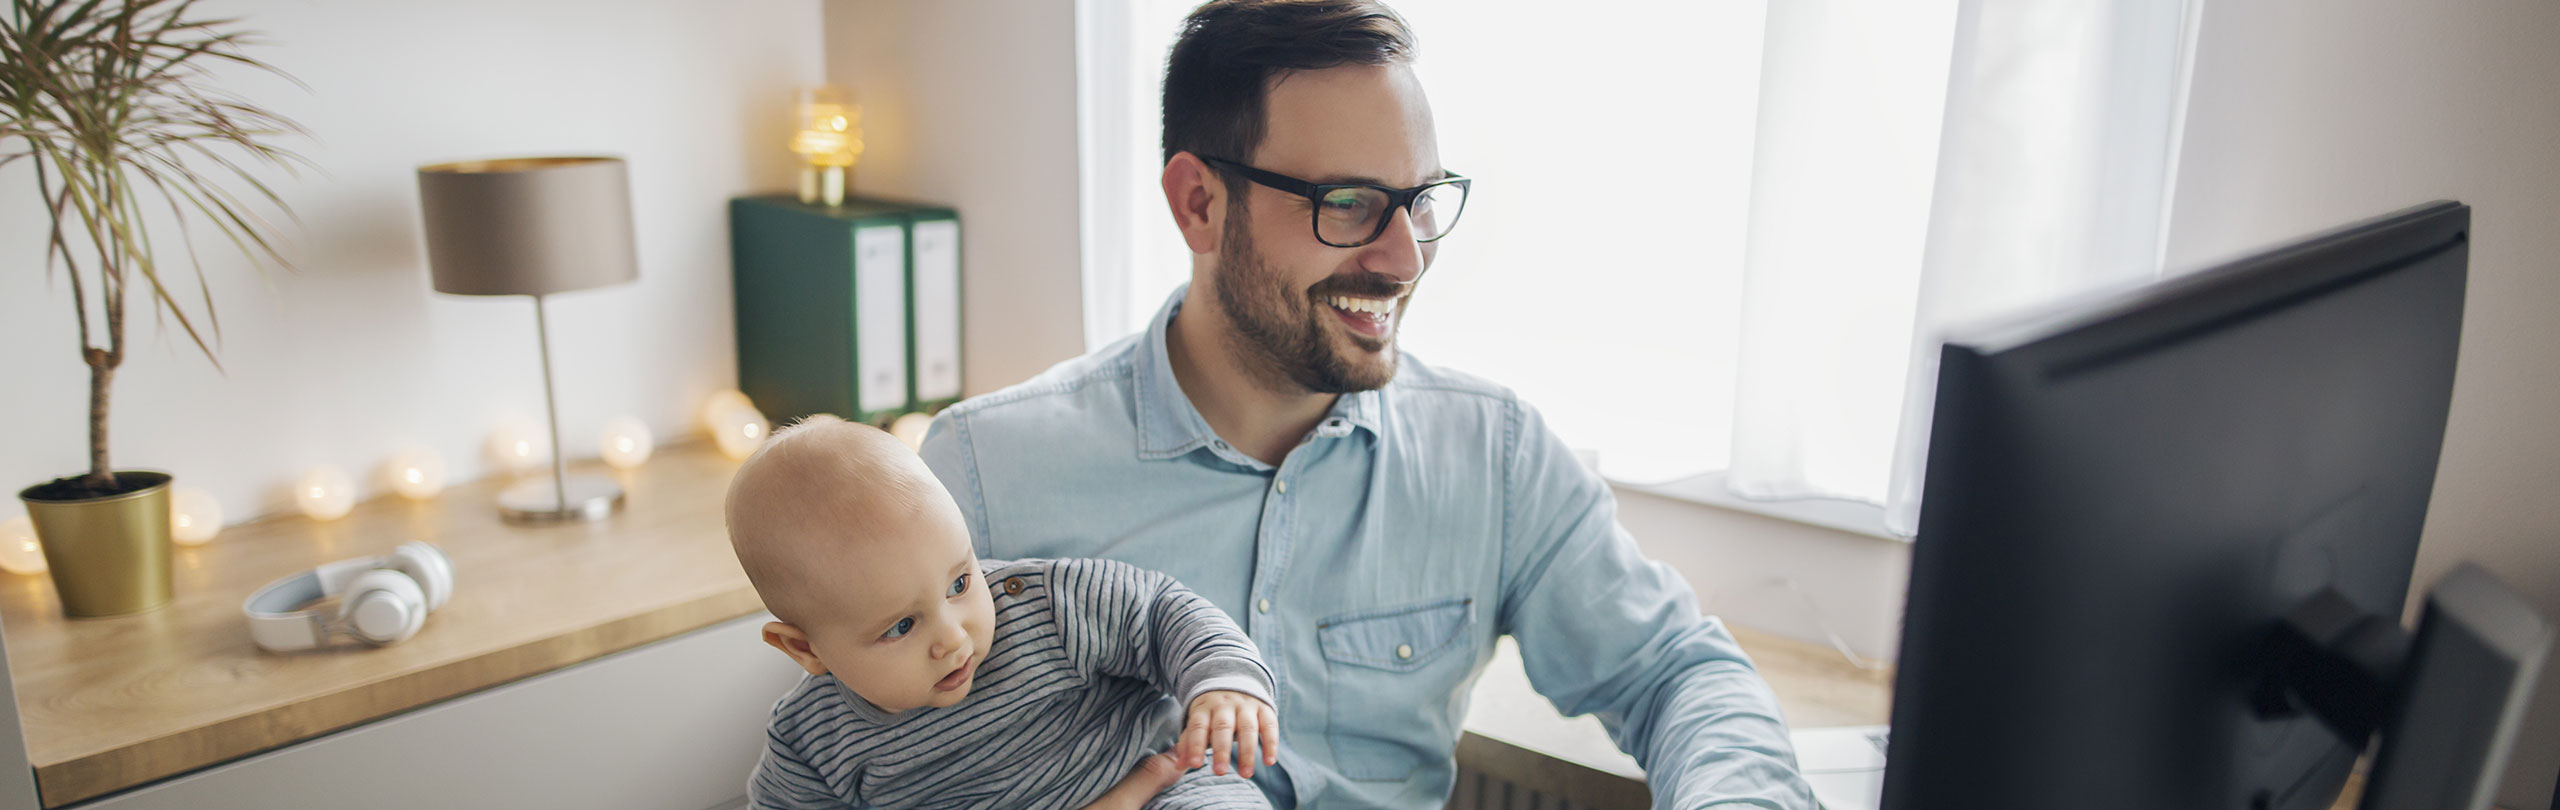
[0,443,763,807]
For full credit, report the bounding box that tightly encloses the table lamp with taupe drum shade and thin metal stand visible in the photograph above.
[417,156,640,523]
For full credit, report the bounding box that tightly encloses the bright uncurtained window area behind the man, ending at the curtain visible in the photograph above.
[1083,0,1792,479]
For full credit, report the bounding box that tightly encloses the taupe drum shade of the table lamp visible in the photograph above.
[417,156,640,295]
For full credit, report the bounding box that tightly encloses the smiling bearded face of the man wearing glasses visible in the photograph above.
[1211,64,1444,395]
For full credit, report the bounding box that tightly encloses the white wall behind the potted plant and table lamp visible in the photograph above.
[0,0,822,523]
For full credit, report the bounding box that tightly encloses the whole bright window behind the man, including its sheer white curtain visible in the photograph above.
[1078,0,2199,531]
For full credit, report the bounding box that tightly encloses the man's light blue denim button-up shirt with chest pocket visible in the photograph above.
[924,290,1815,810]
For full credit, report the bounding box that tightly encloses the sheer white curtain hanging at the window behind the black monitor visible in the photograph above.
[1728,0,2202,533]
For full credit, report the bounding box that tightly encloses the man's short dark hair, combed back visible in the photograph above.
[1165,0,1413,190]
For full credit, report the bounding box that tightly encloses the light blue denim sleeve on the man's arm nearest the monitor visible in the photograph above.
[1495,394,1815,810]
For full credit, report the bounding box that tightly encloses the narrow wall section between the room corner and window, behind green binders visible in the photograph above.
[824,0,1085,395]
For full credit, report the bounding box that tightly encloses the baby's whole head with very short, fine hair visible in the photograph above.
[727,415,996,713]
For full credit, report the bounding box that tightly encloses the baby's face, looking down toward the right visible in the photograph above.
[804,495,996,713]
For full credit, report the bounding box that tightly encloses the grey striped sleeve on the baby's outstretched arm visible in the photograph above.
[1050,559,1275,707]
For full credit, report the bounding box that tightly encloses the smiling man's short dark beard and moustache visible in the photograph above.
[1213,208,1411,395]
